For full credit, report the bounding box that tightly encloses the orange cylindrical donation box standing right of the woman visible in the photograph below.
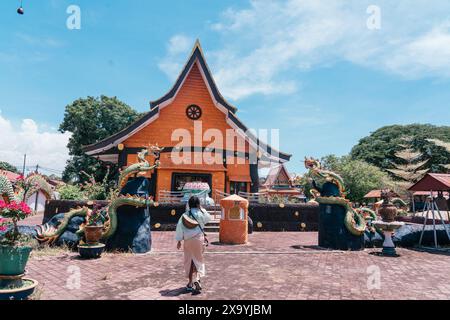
[219,195,248,244]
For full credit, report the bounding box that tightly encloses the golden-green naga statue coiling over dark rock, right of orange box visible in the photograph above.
[305,158,376,236]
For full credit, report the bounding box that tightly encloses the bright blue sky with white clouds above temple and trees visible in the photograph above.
[0,0,450,172]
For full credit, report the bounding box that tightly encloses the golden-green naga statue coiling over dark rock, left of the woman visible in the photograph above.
[37,145,163,244]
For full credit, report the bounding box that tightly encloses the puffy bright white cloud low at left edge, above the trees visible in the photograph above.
[0,113,71,171]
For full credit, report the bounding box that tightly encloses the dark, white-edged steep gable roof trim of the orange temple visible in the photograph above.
[83,40,291,162]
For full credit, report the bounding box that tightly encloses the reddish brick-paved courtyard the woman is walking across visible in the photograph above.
[28,232,450,300]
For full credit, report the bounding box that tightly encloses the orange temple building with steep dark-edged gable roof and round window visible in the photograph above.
[84,41,291,198]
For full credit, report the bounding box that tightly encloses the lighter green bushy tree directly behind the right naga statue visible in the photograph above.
[321,155,396,202]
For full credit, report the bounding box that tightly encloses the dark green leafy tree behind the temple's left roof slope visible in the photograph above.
[59,96,139,182]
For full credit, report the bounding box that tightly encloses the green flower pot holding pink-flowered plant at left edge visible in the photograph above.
[0,246,32,276]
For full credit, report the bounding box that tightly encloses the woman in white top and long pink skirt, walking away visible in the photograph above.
[175,196,211,293]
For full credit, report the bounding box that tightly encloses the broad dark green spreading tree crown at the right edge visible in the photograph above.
[350,124,450,172]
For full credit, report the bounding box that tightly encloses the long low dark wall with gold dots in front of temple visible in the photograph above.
[44,200,319,231]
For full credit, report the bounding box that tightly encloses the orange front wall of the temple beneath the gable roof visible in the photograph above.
[123,64,251,199]
